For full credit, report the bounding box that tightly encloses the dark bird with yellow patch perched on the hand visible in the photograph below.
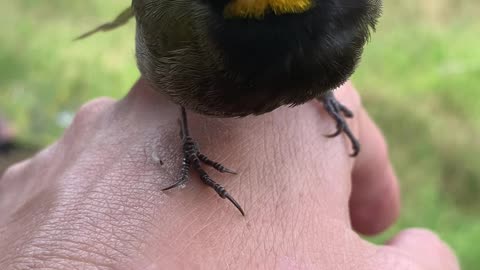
[78,0,382,215]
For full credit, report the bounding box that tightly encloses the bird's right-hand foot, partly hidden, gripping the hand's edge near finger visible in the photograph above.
[318,92,360,157]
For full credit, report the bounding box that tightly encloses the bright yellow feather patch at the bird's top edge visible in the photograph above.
[224,0,313,18]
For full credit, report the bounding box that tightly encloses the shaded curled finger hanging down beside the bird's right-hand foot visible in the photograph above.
[350,106,400,235]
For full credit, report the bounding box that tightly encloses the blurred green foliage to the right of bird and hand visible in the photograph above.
[354,0,480,270]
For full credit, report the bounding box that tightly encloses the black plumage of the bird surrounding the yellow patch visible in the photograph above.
[193,0,380,115]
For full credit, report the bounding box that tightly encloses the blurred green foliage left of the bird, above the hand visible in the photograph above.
[0,0,138,145]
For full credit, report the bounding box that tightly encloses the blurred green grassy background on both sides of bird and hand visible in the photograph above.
[0,0,480,270]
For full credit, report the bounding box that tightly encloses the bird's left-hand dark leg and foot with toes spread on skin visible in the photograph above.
[162,107,245,216]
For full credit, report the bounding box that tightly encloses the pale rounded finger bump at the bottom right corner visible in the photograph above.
[387,229,460,270]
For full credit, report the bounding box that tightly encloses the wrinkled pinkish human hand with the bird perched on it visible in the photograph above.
[0,80,459,270]
